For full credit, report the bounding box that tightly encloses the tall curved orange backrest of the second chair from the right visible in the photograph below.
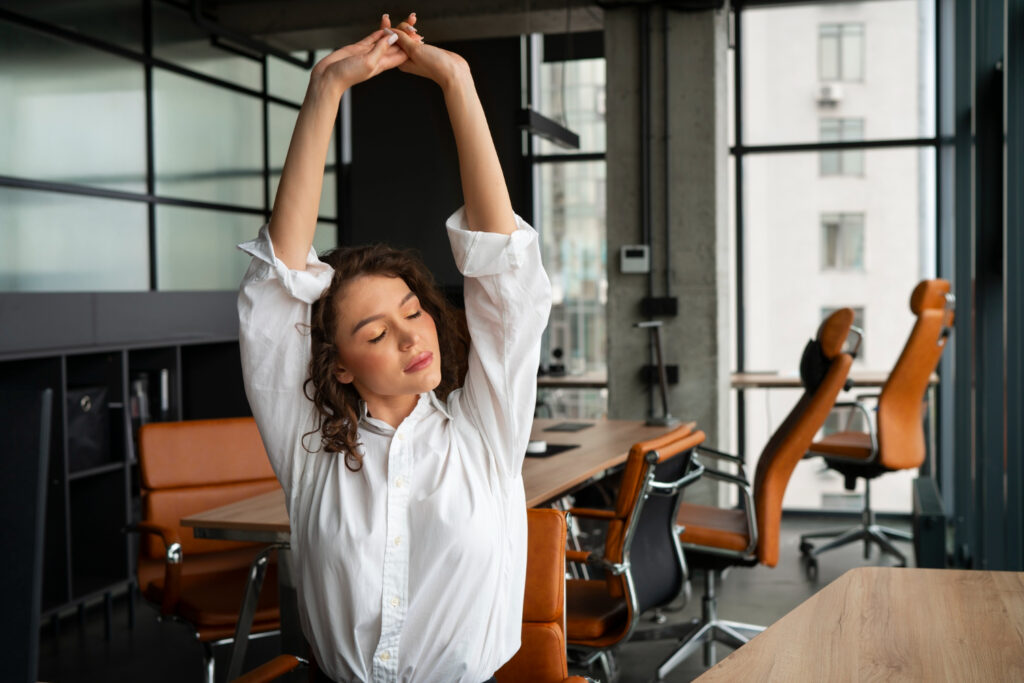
[754,308,853,566]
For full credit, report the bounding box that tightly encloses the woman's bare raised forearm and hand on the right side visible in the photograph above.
[397,32,516,234]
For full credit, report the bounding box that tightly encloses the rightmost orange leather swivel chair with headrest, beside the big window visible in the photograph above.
[800,280,954,577]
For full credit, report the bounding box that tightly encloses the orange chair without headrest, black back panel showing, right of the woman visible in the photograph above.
[566,425,705,680]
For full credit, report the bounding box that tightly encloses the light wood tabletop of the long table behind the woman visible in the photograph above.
[181,419,679,543]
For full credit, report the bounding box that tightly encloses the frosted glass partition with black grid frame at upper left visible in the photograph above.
[0,0,338,292]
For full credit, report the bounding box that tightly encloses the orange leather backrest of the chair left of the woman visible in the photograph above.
[138,418,279,558]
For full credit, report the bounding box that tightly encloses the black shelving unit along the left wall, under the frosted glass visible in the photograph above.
[0,339,251,631]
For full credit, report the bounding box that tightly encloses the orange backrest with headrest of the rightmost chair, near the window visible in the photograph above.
[878,280,953,470]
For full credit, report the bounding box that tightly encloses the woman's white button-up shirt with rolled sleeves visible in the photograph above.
[239,209,551,683]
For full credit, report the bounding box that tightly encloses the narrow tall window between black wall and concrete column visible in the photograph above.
[534,50,608,418]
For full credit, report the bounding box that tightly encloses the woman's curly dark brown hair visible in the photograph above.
[303,245,469,472]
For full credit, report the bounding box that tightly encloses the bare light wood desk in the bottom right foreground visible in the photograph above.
[697,567,1024,683]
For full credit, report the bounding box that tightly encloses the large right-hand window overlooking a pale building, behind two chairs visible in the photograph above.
[733,0,936,512]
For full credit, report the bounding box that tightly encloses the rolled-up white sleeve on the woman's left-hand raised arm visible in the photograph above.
[239,225,334,488]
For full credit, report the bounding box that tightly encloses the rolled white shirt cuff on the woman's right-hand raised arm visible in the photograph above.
[444,207,538,278]
